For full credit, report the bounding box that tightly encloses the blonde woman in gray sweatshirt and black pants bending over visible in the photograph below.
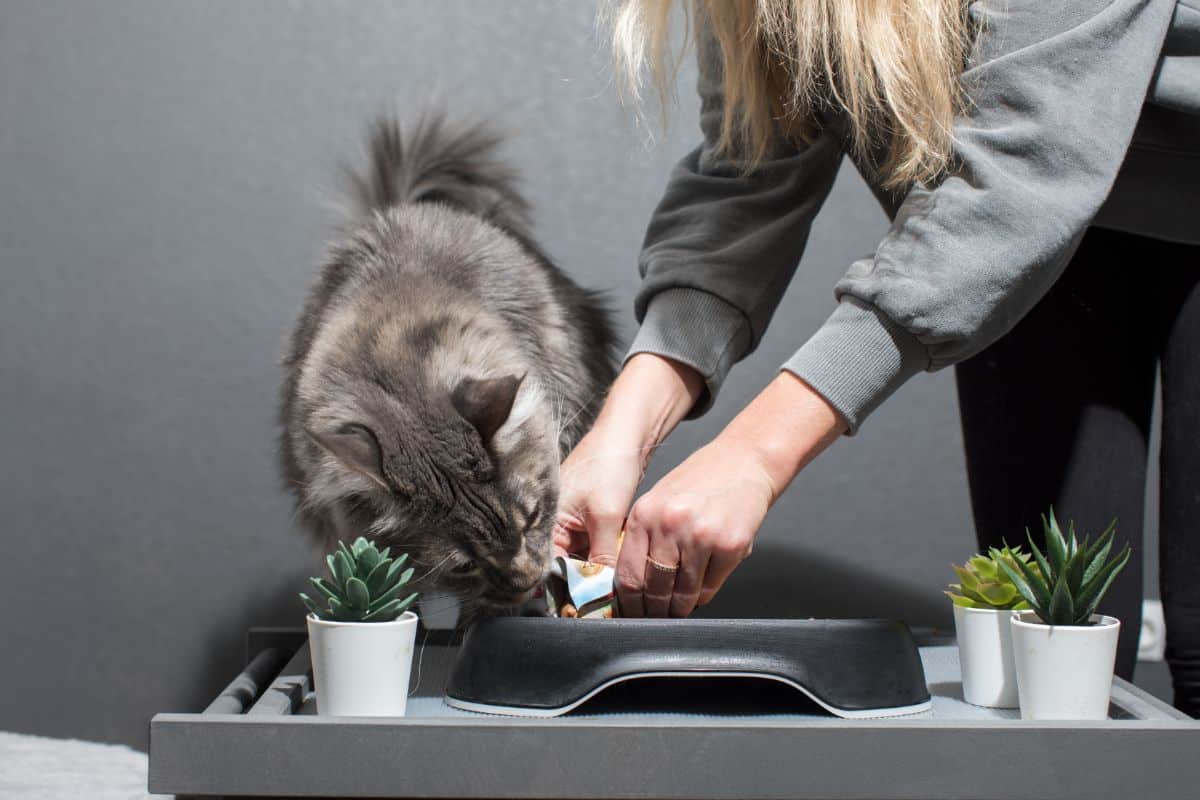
[558,0,1200,714]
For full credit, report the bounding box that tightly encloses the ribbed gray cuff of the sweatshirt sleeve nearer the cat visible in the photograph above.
[625,288,750,420]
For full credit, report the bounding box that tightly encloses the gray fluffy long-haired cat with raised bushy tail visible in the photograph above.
[281,115,614,607]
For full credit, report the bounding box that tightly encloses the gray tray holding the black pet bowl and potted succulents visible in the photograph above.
[150,622,1200,800]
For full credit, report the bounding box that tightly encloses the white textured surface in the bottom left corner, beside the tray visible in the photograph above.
[0,732,168,800]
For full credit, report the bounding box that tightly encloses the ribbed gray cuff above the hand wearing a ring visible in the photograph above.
[782,296,929,434]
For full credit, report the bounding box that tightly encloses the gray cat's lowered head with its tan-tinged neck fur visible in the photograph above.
[298,297,559,607]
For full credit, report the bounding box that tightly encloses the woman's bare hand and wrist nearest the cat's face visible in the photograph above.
[554,353,704,566]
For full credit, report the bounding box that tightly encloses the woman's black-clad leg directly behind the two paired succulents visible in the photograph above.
[956,228,1158,679]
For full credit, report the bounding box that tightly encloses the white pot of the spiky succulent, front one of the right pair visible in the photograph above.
[1012,612,1121,720]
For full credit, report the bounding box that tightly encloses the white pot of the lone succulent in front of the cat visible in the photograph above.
[308,612,416,717]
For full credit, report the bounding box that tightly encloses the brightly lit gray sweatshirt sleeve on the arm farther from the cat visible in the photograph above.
[784,0,1175,431]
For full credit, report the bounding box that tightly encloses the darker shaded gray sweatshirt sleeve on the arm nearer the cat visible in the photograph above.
[625,21,841,417]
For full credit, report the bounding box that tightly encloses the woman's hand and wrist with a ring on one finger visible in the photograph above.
[617,372,846,616]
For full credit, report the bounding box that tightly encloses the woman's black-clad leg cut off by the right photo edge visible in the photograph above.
[1158,253,1200,717]
